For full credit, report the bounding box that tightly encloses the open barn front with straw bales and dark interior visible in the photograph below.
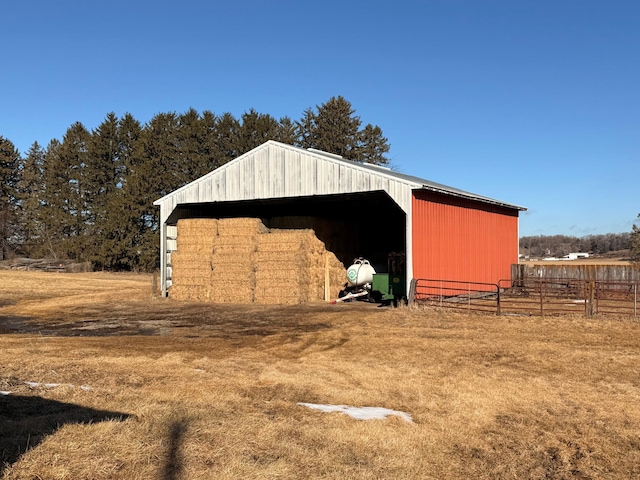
[167,192,406,303]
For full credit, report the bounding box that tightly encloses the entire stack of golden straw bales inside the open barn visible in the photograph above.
[170,218,346,304]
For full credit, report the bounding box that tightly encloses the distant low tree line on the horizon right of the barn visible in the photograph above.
[520,232,637,258]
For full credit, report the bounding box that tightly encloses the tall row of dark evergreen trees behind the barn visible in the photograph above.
[0,97,389,271]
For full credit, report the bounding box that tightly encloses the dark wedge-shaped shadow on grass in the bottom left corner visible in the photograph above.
[0,395,130,476]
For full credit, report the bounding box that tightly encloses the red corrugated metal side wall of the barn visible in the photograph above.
[412,191,518,283]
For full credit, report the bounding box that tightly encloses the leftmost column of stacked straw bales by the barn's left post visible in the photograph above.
[171,218,218,301]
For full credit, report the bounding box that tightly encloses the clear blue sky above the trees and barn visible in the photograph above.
[0,0,640,236]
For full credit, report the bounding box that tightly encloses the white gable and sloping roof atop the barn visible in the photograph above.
[154,140,526,222]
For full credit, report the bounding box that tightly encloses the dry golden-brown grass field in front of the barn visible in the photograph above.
[0,271,640,480]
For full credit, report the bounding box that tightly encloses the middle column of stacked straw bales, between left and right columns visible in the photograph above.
[211,218,268,303]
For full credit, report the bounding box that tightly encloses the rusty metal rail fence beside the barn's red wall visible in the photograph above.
[412,278,640,319]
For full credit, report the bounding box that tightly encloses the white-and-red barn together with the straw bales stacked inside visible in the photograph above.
[154,141,525,303]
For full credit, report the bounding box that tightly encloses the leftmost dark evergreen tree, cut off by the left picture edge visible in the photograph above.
[0,136,20,260]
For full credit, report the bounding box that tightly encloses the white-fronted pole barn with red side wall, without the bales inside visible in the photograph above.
[154,140,526,302]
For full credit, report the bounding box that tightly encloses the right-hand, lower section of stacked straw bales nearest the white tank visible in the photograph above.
[254,230,345,304]
